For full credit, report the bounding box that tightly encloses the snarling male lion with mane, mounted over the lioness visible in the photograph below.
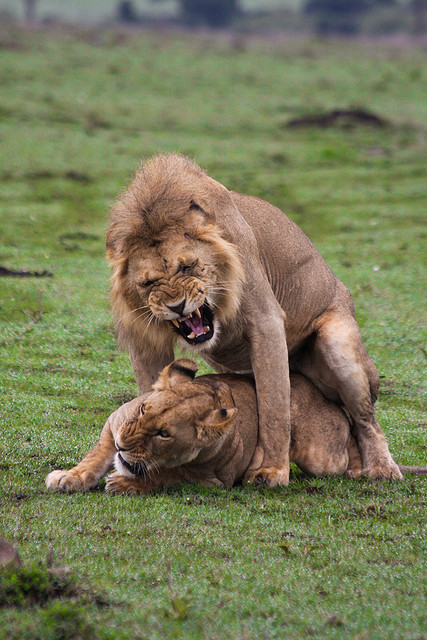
[107,154,402,486]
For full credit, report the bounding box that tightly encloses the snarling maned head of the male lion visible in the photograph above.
[107,155,243,350]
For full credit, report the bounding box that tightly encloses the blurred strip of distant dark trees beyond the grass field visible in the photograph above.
[0,0,427,35]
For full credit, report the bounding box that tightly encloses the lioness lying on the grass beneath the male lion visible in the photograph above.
[46,358,421,493]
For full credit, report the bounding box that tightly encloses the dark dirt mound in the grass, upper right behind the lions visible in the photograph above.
[286,109,389,129]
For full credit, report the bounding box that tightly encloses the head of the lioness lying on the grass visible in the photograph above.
[115,358,237,477]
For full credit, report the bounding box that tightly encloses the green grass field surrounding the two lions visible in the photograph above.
[0,26,427,640]
